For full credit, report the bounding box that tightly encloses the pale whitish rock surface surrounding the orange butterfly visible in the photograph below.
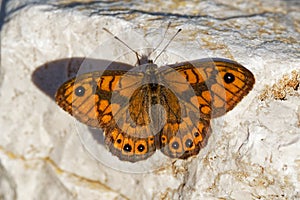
[0,0,300,200]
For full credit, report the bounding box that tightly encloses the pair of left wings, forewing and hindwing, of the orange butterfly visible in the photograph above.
[56,70,156,162]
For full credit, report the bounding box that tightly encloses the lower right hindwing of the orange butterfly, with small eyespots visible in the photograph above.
[160,85,210,159]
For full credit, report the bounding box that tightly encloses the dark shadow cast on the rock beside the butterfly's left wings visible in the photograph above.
[31,57,133,145]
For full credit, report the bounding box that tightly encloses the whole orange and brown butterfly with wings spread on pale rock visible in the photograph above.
[56,56,255,162]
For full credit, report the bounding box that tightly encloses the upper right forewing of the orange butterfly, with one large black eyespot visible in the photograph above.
[165,58,255,119]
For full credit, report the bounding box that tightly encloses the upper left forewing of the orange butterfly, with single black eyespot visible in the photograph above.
[55,70,131,128]
